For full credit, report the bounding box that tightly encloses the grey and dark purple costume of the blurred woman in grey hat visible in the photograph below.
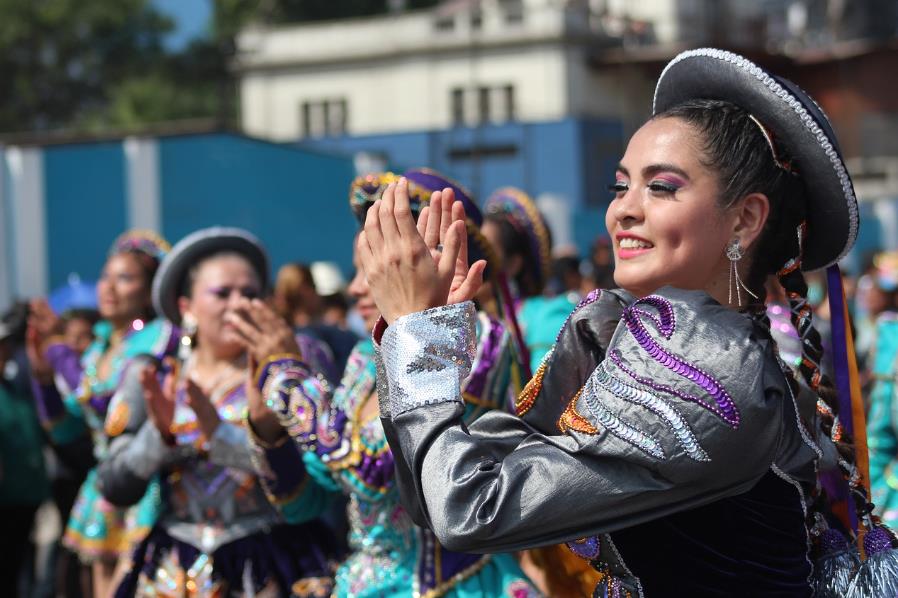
[98,338,336,597]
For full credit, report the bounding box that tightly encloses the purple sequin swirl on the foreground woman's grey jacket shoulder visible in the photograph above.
[623,295,740,428]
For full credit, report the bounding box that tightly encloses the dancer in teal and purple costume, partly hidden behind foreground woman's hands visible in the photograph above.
[234,175,536,598]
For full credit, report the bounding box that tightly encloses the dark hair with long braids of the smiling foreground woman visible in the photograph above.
[654,100,871,536]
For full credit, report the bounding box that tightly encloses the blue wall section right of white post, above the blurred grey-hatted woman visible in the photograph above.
[159,134,356,273]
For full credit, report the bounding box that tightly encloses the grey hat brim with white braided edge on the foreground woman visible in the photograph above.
[653,48,859,271]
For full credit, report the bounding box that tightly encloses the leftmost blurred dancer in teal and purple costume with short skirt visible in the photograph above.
[29,231,176,596]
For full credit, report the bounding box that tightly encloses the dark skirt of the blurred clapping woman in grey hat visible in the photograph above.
[115,521,342,598]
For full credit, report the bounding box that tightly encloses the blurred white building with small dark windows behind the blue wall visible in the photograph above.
[235,0,680,140]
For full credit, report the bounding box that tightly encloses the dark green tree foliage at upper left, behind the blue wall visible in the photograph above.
[0,0,436,132]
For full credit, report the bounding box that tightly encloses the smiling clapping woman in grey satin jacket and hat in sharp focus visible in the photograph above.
[358,49,895,596]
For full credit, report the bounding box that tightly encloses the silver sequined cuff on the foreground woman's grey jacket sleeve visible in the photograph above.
[378,301,477,417]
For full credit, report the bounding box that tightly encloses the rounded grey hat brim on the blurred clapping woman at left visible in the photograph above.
[153,227,268,324]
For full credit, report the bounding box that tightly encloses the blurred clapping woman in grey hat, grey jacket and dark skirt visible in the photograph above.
[99,228,335,597]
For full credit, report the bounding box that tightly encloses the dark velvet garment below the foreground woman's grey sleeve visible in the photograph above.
[611,473,812,598]
